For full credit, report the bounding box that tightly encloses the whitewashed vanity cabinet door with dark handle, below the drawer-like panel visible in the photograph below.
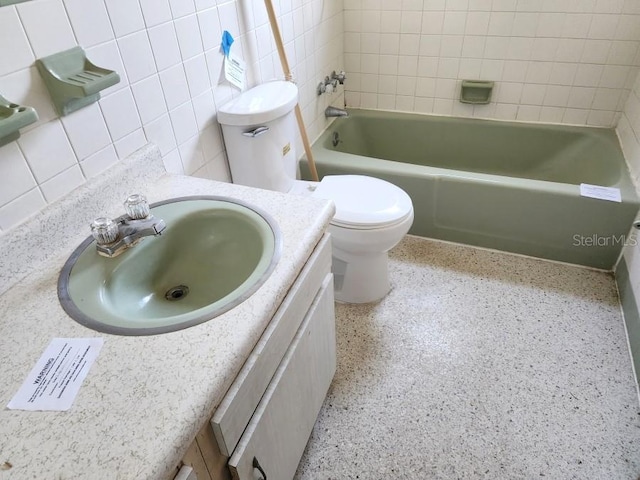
[229,274,336,480]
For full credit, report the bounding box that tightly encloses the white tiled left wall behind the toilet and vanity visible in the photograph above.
[0,0,344,232]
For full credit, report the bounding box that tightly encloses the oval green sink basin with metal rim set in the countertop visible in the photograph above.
[58,197,282,335]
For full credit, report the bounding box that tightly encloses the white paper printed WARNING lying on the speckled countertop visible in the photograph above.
[7,338,104,411]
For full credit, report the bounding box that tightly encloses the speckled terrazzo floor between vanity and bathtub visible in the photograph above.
[296,237,640,480]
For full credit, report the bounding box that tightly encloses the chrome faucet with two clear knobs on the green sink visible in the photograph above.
[91,193,167,257]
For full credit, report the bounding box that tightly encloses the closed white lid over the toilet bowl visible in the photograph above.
[313,175,413,228]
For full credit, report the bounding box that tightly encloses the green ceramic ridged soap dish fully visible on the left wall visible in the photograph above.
[36,47,120,116]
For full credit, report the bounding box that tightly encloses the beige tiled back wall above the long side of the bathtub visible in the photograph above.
[344,0,640,126]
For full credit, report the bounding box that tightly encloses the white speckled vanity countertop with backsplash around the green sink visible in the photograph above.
[0,146,333,480]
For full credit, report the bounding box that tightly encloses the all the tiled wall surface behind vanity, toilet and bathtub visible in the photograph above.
[0,0,640,239]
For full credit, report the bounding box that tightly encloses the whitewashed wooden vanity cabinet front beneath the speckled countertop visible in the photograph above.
[176,234,336,480]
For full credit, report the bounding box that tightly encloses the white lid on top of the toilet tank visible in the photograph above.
[218,80,298,126]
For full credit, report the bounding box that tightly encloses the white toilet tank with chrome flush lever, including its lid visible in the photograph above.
[218,81,298,192]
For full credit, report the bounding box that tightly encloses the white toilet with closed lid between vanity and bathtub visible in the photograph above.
[218,81,413,303]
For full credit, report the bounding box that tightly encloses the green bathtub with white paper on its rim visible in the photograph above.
[300,110,640,270]
